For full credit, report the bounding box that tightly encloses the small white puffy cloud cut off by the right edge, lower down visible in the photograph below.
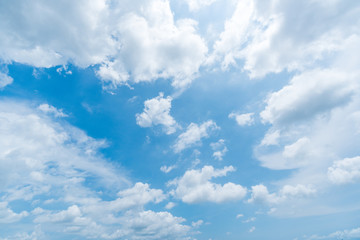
[328,156,360,184]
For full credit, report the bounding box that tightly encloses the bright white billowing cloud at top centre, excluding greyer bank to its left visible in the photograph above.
[98,0,207,88]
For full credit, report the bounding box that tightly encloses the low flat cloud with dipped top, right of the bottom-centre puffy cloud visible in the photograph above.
[248,184,316,205]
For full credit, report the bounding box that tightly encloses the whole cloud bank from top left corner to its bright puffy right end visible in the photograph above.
[0,0,207,89]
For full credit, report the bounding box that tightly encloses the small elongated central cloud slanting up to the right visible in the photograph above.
[173,120,219,153]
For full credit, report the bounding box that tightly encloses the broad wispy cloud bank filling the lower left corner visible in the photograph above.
[0,100,192,239]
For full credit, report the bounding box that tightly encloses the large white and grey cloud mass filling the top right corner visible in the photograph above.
[208,0,360,78]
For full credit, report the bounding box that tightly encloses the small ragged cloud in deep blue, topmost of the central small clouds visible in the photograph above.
[136,93,178,134]
